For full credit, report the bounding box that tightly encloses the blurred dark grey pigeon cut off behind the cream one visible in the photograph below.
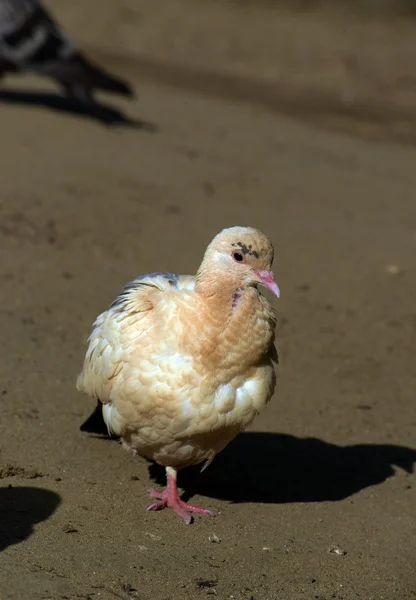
[0,0,133,104]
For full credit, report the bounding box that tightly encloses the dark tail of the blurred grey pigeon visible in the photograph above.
[62,52,134,97]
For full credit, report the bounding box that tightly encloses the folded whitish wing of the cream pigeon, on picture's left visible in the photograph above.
[77,273,184,435]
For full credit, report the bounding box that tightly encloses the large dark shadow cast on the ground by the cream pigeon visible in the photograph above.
[81,406,416,504]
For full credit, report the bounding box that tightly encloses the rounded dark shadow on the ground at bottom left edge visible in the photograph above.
[0,487,61,552]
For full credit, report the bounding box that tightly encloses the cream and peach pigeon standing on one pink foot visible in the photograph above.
[77,227,280,524]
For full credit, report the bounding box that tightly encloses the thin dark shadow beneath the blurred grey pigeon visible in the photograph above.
[0,90,158,128]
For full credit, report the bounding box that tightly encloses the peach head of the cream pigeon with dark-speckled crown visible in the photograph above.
[197,227,280,297]
